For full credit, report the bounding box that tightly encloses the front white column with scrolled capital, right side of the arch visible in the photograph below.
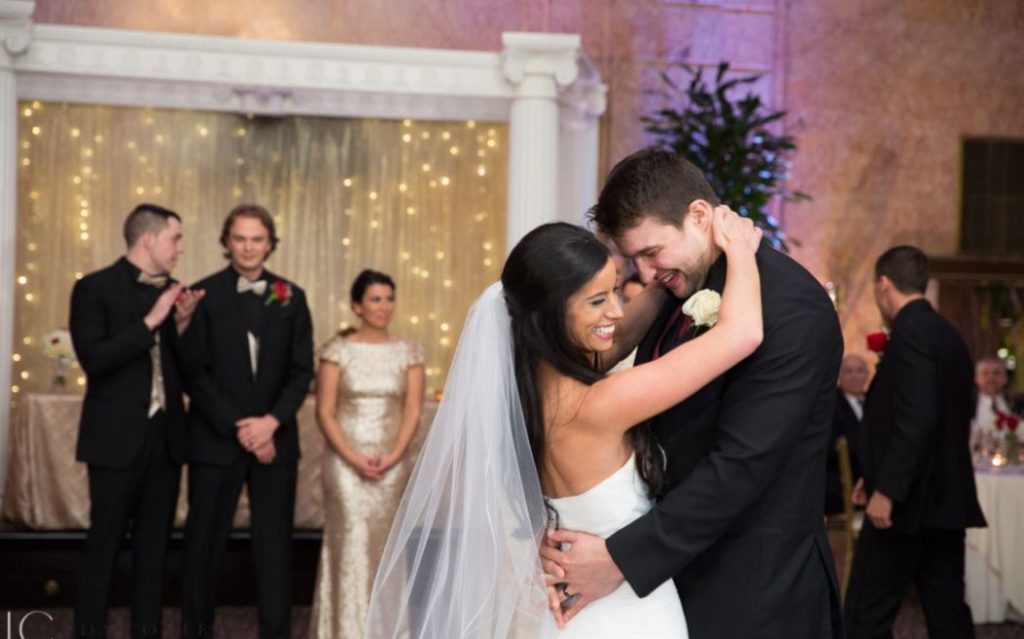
[502,33,581,250]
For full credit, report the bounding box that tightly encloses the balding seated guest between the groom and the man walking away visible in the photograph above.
[825,354,867,515]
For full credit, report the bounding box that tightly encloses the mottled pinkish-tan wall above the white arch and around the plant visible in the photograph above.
[29,0,1024,350]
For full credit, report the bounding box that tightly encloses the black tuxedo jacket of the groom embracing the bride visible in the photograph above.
[607,247,843,639]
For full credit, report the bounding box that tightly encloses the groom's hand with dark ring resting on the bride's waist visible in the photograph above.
[541,530,623,623]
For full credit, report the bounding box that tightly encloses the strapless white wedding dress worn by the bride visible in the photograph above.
[540,456,689,639]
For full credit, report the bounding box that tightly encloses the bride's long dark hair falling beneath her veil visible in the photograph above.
[502,222,666,495]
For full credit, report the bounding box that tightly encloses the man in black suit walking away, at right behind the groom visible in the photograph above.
[846,246,985,639]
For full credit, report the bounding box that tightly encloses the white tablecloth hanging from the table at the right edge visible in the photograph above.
[965,467,1024,624]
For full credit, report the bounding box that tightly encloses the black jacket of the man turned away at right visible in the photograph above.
[863,299,985,534]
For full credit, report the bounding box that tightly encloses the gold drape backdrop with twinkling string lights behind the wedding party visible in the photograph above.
[14,101,507,403]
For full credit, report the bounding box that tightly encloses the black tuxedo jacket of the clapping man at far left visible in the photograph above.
[70,258,187,468]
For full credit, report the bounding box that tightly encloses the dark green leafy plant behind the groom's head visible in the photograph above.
[642,62,810,252]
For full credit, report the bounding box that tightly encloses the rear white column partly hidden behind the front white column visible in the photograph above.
[558,58,607,224]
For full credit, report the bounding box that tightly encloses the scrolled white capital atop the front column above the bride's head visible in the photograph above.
[502,32,582,93]
